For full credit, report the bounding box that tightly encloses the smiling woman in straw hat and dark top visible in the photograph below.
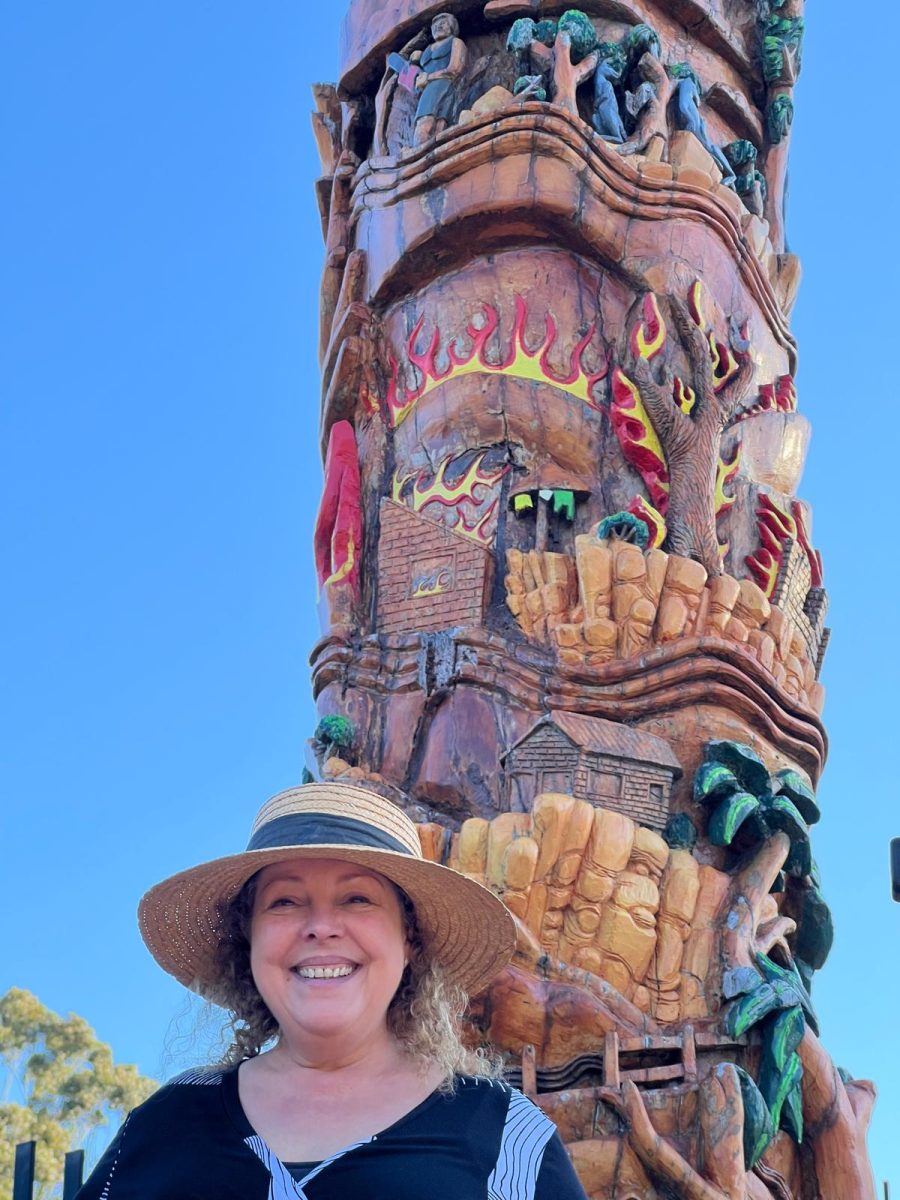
[79,784,584,1200]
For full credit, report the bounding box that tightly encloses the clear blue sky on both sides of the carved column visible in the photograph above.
[0,0,900,1189]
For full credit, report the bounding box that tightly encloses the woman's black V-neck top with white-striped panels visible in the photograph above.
[78,1068,584,1200]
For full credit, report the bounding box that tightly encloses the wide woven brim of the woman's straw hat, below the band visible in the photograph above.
[138,844,516,1003]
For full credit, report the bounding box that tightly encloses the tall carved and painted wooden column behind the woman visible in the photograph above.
[308,0,874,1200]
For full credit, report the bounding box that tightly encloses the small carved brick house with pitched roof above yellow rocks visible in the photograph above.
[500,712,682,829]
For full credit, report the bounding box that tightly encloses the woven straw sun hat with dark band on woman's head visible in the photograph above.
[138,784,516,1001]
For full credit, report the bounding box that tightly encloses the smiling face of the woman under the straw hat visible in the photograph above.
[250,858,408,1050]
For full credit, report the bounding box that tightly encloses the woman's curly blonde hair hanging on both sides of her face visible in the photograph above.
[210,876,502,1086]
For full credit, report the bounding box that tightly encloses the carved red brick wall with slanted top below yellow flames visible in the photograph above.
[378,500,490,634]
